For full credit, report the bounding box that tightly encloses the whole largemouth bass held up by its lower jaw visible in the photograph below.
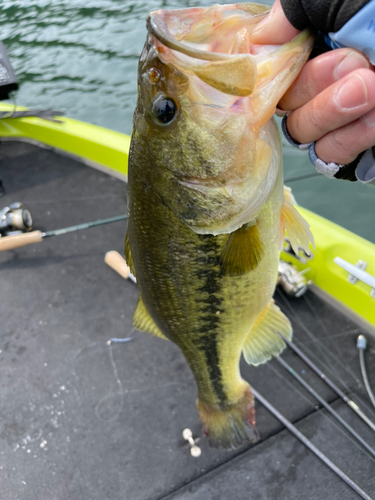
[125,4,313,448]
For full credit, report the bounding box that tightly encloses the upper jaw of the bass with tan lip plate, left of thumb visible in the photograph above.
[146,4,269,97]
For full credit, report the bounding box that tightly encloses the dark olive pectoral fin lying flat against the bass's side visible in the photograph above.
[221,223,264,276]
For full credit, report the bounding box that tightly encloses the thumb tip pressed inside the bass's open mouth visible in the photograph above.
[250,0,299,45]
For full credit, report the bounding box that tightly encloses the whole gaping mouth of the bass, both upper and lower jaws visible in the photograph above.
[146,3,313,107]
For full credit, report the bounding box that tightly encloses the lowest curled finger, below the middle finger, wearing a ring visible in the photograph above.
[315,108,375,165]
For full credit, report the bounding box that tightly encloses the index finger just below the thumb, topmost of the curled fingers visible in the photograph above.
[278,49,370,111]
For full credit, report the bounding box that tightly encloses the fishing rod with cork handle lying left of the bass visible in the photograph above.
[0,215,128,252]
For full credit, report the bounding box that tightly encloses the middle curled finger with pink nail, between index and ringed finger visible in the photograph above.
[287,69,375,144]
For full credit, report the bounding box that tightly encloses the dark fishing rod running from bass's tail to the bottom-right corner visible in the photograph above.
[252,387,373,500]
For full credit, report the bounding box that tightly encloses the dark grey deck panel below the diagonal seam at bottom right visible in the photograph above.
[163,402,375,500]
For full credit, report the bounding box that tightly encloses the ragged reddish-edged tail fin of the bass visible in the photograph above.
[197,384,259,450]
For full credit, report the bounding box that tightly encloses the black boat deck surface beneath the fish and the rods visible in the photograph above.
[0,143,375,500]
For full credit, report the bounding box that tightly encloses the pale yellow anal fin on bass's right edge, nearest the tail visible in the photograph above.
[243,300,293,366]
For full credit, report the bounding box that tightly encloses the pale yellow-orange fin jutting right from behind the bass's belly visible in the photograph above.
[280,187,315,255]
